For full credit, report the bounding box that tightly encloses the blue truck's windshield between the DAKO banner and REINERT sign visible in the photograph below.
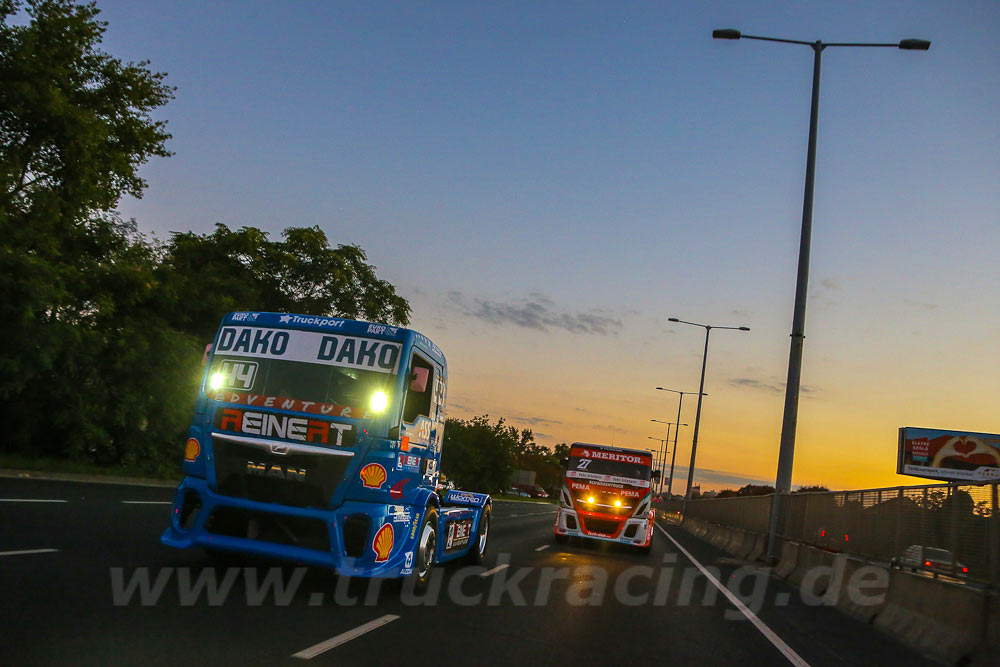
[206,356,395,418]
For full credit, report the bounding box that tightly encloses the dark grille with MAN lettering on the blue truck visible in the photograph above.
[212,438,350,508]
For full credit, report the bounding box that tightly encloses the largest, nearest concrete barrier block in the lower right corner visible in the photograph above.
[874,570,995,664]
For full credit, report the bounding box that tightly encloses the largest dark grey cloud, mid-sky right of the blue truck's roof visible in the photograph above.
[448,291,623,336]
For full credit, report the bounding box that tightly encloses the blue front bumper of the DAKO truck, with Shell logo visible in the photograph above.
[160,477,423,577]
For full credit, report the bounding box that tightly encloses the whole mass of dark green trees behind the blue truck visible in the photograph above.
[0,5,410,473]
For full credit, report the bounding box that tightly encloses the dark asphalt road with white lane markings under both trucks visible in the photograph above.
[0,479,930,667]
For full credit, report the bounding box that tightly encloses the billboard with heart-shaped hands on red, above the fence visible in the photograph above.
[896,426,1000,483]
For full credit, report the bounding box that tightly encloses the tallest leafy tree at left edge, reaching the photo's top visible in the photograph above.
[0,0,173,470]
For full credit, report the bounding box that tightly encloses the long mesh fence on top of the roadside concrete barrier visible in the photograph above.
[660,484,1000,586]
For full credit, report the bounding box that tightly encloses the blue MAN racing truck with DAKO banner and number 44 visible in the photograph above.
[161,312,491,590]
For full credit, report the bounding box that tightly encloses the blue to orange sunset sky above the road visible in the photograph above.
[98,0,1000,491]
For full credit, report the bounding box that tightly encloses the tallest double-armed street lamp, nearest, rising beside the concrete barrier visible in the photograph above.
[712,28,931,562]
